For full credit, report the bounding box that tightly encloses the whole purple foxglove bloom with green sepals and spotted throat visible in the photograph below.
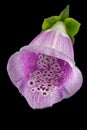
[7,6,83,109]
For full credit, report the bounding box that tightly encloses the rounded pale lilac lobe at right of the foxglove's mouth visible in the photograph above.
[62,66,83,98]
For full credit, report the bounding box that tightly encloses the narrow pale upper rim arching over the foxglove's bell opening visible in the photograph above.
[20,45,75,66]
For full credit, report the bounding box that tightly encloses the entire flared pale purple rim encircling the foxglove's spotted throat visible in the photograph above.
[7,45,82,109]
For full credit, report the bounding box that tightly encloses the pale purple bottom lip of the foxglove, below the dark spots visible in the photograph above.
[19,84,63,109]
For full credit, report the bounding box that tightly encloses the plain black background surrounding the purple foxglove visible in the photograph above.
[0,0,87,128]
